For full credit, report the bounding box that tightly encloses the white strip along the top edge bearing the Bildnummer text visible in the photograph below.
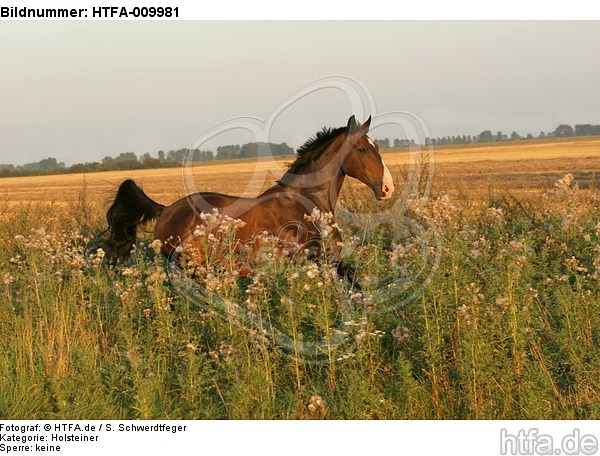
[1,0,600,19]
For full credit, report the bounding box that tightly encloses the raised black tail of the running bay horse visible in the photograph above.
[101,179,165,263]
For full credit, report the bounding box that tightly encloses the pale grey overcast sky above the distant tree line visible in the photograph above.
[0,21,600,165]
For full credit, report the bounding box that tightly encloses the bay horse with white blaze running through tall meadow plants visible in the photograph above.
[101,116,394,284]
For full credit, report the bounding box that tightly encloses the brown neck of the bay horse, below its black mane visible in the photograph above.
[280,140,345,213]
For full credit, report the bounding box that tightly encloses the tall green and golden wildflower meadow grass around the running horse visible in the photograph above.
[0,163,600,419]
